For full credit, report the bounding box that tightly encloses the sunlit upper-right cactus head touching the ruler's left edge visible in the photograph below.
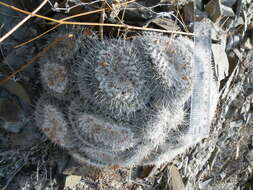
[136,33,193,103]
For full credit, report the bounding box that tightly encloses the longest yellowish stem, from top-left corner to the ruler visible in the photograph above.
[0,2,194,36]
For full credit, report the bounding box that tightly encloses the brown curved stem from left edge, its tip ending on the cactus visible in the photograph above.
[0,35,73,85]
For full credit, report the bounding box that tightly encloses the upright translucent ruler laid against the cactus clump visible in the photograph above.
[187,22,214,143]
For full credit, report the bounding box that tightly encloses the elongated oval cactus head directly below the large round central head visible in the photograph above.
[69,100,136,151]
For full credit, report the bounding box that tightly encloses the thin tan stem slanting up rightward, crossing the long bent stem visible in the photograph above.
[14,0,136,48]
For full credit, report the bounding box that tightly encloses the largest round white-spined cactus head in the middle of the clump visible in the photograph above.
[77,40,151,116]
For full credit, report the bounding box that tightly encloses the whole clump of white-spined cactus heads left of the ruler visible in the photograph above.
[35,27,211,166]
